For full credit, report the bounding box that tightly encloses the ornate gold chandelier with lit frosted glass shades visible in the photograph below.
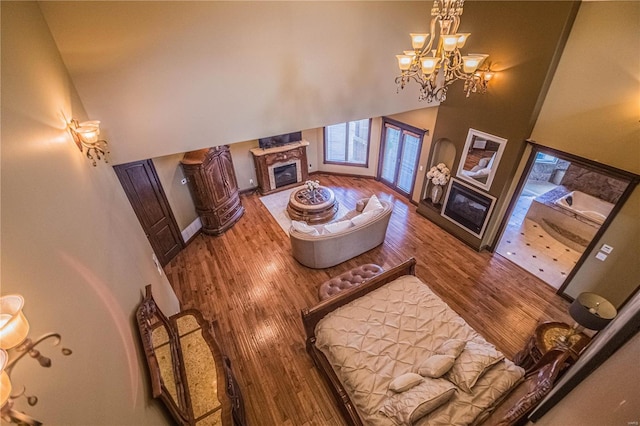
[396,0,494,102]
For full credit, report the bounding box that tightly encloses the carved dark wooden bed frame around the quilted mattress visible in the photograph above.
[301,258,568,426]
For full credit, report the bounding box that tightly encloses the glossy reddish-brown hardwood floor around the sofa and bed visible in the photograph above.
[165,174,570,425]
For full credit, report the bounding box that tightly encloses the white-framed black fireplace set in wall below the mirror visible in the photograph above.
[442,179,496,238]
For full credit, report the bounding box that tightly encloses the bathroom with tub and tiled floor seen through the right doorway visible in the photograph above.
[495,145,630,292]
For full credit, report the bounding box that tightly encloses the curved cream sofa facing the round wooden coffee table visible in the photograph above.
[289,195,393,269]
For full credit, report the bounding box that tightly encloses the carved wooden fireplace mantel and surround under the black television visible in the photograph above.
[250,140,309,195]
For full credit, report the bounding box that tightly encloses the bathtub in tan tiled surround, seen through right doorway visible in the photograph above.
[526,187,613,253]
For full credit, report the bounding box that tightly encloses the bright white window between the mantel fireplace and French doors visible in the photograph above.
[325,119,369,165]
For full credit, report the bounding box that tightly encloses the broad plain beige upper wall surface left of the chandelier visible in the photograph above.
[41,1,431,164]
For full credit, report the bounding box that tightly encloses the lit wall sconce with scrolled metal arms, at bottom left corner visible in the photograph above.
[0,294,71,426]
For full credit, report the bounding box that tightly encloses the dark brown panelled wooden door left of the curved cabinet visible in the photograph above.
[113,160,184,266]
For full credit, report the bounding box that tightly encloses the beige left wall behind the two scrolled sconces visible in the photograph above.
[0,2,178,425]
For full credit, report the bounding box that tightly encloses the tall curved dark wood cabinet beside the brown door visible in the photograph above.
[181,145,244,235]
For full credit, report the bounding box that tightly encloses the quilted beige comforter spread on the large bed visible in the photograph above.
[316,276,524,425]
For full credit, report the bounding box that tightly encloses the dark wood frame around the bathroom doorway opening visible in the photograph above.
[489,140,640,301]
